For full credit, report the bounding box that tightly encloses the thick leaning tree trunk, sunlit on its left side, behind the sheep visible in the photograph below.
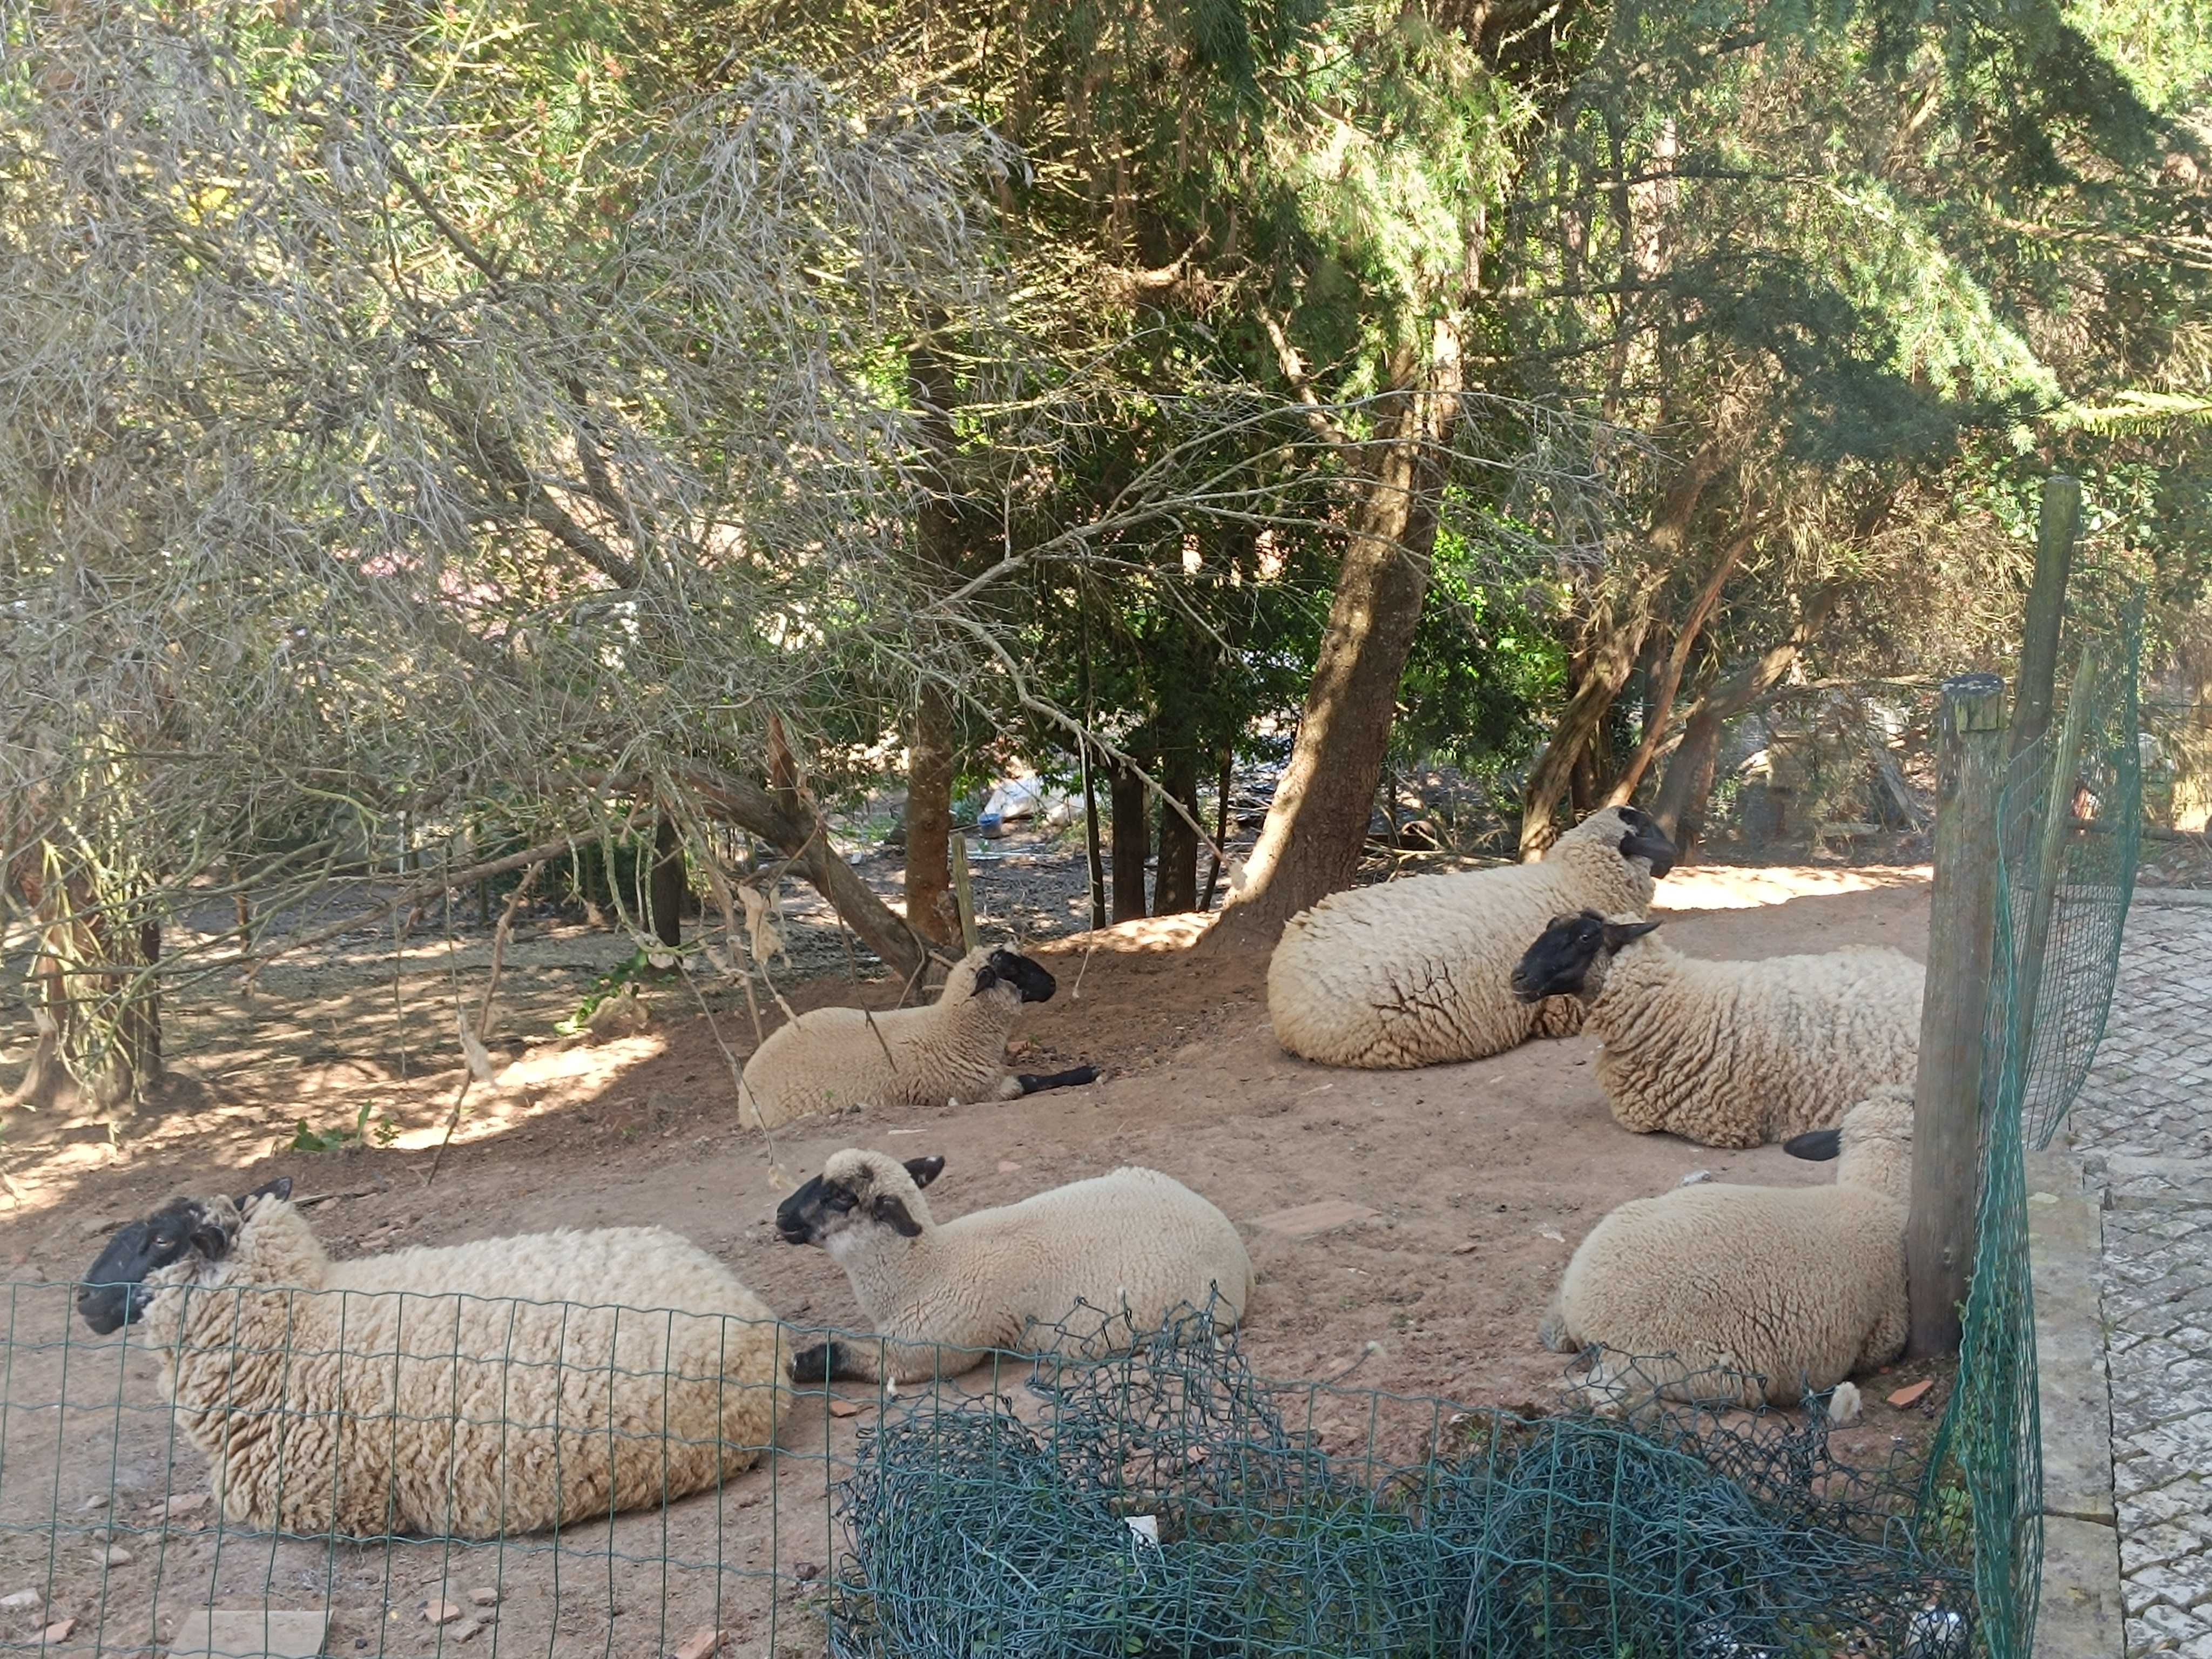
[1208,323,1462,951]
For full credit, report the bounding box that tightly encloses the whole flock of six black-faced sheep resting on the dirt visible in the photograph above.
[77,807,1922,1537]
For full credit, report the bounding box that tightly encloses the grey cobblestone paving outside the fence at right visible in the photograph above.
[2073,902,2212,1659]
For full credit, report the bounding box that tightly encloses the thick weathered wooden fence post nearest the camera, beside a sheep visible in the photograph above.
[1905,675,2004,1358]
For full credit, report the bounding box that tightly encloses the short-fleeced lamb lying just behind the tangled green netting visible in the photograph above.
[777,1146,1254,1382]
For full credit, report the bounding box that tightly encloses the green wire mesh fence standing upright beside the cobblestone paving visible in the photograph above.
[1931,615,2141,1659]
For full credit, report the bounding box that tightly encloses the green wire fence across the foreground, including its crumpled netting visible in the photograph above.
[0,1285,1973,1659]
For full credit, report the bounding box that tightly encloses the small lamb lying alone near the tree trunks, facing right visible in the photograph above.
[739,945,1100,1128]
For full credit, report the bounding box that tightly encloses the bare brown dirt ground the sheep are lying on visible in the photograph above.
[0,865,1973,1655]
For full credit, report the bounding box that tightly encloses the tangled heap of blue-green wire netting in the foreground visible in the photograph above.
[830,1318,1971,1659]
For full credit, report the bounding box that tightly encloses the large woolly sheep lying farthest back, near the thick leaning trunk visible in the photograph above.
[1267,807,1675,1070]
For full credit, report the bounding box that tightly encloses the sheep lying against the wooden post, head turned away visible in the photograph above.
[1537,1084,1913,1425]
